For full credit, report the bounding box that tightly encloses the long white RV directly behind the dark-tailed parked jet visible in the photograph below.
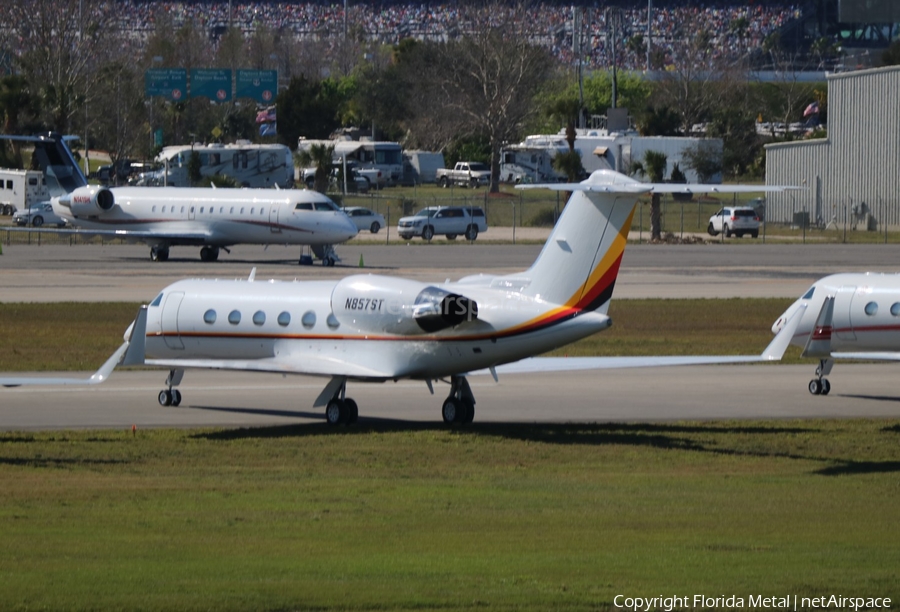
[138,141,294,188]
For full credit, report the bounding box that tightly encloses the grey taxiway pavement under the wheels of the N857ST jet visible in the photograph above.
[0,363,900,430]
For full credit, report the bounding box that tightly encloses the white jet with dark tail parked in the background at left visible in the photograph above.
[4,134,357,266]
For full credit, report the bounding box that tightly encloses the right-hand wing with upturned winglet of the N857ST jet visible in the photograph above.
[471,305,804,376]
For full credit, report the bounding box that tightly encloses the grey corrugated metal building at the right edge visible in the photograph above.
[766,66,900,229]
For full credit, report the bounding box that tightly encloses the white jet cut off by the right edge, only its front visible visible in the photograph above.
[772,273,900,395]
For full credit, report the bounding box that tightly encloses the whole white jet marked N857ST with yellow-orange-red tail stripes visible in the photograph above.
[0,170,793,424]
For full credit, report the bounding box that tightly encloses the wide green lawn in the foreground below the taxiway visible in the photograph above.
[0,420,900,611]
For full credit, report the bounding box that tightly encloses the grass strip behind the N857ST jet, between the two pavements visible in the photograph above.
[0,299,797,372]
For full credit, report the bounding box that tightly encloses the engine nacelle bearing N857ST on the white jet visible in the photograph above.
[331,275,478,335]
